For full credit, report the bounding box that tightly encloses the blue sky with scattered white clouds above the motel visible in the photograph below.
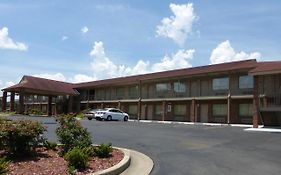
[0,0,281,89]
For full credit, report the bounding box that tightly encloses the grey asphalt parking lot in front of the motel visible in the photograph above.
[3,117,281,175]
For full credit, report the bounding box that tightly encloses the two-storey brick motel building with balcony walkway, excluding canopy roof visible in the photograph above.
[2,60,281,127]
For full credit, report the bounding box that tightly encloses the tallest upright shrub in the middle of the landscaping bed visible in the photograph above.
[56,115,92,154]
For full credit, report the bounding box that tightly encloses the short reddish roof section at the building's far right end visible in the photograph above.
[250,61,281,75]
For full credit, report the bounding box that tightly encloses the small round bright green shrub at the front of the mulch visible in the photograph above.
[64,147,89,170]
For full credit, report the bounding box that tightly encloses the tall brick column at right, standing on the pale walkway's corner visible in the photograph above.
[253,76,260,128]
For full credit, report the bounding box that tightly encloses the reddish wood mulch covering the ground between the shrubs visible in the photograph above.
[0,148,124,175]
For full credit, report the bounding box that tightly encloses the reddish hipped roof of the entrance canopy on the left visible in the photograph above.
[3,75,79,95]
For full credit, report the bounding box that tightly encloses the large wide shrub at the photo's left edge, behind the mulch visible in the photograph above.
[0,120,45,155]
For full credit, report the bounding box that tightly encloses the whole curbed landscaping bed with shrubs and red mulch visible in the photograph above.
[0,115,124,175]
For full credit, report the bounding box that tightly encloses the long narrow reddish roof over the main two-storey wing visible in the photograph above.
[74,59,257,88]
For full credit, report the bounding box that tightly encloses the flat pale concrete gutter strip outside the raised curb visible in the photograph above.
[121,150,153,175]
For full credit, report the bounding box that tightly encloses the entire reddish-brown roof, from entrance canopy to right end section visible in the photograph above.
[7,60,281,95]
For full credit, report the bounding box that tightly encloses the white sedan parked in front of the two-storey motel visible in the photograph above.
[95,108,129,121]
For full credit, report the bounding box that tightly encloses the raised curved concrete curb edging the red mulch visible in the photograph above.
[88,147,131,175]
